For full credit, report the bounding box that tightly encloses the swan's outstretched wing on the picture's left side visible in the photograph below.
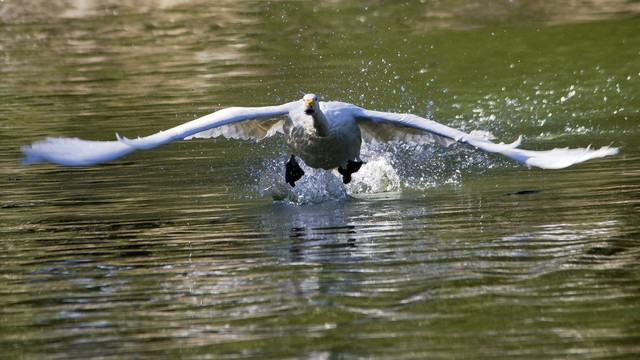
[20,101,302,166]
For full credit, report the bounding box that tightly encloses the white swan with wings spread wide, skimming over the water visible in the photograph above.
[20,94,618,186]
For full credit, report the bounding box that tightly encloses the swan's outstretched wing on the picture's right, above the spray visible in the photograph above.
[352,106,618,169]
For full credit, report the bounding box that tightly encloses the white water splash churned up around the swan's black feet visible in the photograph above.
[252,138,508,205]
